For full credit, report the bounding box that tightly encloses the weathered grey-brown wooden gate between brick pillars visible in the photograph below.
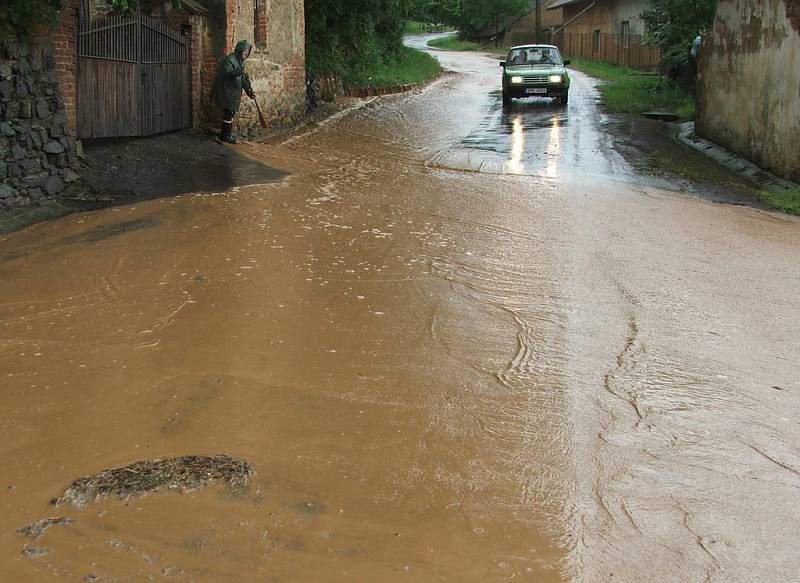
[77,2,191,138]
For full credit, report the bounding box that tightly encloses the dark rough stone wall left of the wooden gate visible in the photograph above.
[0,41,78,210]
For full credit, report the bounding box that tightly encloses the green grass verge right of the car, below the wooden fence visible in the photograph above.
[570,59,695,120]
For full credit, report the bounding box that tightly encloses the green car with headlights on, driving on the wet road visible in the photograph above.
[500,45,569,105]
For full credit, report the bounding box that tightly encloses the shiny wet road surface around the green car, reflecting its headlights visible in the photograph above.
[410,32,624,181]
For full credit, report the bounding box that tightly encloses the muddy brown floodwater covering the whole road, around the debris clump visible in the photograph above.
[0,37,800,582]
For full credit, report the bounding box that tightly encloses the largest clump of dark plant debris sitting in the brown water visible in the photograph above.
[55,455,253,506]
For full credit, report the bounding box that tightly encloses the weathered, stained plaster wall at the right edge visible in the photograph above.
[696,0,800,181]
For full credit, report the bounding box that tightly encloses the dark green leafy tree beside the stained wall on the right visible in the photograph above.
[642,0,717,76]
